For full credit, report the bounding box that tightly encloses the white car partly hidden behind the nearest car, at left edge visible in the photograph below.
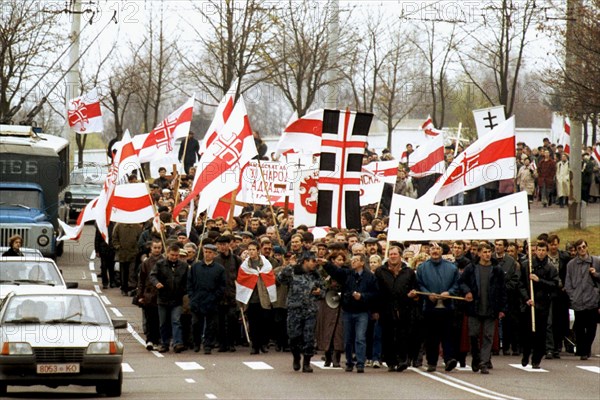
[0,257,78,300]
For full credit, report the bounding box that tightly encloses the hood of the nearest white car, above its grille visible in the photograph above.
[0,324,117,347]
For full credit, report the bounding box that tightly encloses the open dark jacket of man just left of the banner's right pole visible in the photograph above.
[458,265,507,318]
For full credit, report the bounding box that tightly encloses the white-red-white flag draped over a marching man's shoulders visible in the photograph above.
[235,255,277,304]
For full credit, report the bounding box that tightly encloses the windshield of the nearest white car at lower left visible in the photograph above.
[2,294,110,325]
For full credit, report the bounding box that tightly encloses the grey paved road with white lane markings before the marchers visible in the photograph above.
[8,205,600,400]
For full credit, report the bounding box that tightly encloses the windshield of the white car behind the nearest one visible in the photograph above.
[0,260,64,286]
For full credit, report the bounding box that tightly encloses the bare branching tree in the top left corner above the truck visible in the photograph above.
[0,0,61,123]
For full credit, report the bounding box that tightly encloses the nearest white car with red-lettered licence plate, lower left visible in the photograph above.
[0,286,127,397]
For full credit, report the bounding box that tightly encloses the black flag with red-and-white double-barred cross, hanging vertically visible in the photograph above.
[316,110,373,229]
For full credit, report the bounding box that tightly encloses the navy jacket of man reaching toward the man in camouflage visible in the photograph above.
[323,262,379,313]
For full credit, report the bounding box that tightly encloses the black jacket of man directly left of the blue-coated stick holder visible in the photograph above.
[375,263,419,320]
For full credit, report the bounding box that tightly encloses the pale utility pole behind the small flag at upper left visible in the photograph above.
[62,0,81,141]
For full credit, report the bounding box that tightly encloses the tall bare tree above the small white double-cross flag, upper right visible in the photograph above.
[458,0,540,117]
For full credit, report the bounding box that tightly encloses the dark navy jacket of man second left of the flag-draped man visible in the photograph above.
[187,261,225,314]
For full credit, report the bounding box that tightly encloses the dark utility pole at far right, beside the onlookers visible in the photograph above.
[565,0,584,229]
